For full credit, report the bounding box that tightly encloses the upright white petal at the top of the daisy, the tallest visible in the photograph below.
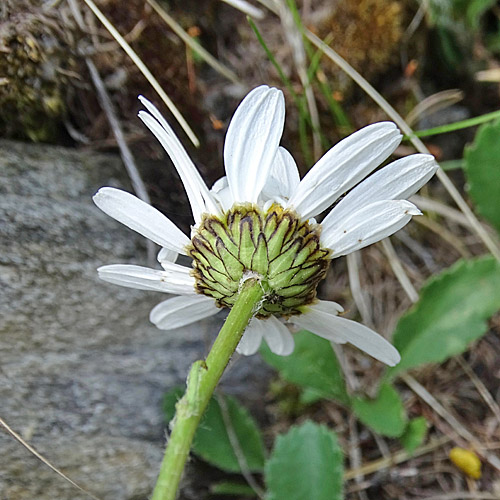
[224,85,285,203]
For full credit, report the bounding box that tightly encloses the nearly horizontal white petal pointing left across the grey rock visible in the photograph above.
[97,264,196,295]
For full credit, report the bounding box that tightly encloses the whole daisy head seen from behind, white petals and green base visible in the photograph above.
[94,85,437,366]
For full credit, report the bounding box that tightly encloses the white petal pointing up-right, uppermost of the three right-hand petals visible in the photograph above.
[287,122,402,219]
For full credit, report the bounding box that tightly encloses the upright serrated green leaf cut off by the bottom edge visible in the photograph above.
[265,421,343,500]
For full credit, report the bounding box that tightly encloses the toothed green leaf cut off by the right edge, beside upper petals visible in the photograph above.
[465,122,500,231]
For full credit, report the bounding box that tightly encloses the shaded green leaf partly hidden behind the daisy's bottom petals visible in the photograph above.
[260,331,349,404]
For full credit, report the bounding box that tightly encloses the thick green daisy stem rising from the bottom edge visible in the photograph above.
[151,278,264,500]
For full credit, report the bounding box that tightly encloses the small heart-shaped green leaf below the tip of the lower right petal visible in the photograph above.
[352,384,407,437]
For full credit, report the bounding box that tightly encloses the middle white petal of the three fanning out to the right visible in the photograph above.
[321,154,438,230]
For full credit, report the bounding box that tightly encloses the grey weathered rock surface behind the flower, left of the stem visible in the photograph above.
[0,141,266,500]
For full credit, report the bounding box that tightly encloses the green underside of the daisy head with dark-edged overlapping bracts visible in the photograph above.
[188,204,330,317]
